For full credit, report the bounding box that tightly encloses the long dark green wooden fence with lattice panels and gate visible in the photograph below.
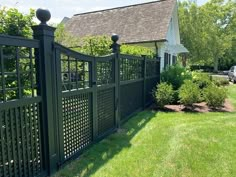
[0,10,160,177]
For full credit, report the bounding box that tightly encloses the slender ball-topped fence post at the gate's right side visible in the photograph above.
[111,34,120,128]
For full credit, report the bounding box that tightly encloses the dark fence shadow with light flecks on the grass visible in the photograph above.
[54,111,156,177]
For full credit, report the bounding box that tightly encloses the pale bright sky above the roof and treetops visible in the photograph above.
[0,0,207,23]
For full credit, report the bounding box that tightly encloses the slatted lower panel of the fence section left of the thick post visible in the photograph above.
[0,103,42,177]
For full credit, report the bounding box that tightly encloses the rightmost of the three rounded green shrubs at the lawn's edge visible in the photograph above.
[203,84,227,108]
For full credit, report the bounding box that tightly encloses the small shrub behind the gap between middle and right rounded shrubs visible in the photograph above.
[192,72,212,89]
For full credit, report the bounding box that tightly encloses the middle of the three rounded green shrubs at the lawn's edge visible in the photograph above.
[179,80,201,106]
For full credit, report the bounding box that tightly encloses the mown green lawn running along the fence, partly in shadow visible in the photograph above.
[55,86,236,177]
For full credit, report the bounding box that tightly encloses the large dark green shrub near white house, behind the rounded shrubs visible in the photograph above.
[161,65,192,90]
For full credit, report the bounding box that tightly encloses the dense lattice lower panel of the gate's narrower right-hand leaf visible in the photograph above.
[97,88,115,135]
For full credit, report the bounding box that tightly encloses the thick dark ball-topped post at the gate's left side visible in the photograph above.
[32,9,58,175]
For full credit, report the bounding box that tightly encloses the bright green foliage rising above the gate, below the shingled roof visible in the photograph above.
[55,27,155,58]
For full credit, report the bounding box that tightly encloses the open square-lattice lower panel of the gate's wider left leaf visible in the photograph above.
[62,93,93,159]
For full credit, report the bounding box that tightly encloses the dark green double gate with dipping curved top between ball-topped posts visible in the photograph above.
[52,44,116,163]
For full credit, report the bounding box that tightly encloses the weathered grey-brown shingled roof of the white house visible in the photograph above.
[65,0,176,43]
